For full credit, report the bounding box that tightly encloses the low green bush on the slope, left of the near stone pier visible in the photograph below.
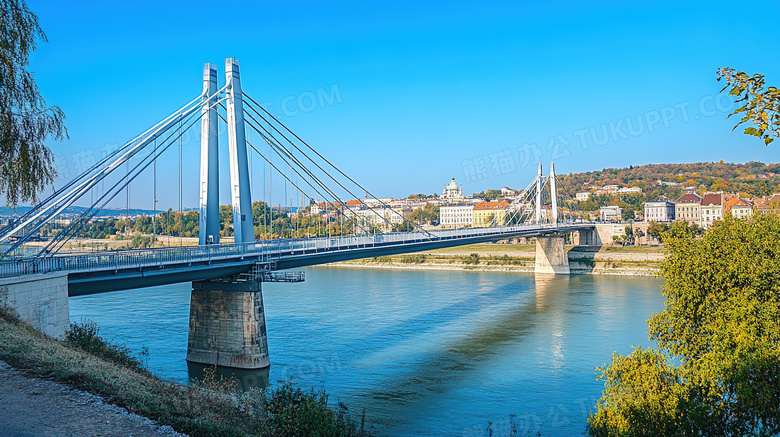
[66,320,149,372]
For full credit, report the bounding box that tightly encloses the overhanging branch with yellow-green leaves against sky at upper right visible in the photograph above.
[718,68,780,146]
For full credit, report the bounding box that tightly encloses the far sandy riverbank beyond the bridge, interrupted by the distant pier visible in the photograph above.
[329,244,664,276]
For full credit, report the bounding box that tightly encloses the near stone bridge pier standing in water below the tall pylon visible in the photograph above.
[187,280,270,369]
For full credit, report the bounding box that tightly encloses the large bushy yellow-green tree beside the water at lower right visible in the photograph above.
[588,214,780,436]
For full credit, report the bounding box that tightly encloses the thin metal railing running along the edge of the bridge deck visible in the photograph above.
[0,220,584,277]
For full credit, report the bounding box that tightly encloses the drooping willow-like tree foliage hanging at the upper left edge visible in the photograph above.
[0,0,68,205]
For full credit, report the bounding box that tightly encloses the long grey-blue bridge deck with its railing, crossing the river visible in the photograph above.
[0,223,593,296]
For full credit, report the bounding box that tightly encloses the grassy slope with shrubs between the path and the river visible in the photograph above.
[0,302,374,437]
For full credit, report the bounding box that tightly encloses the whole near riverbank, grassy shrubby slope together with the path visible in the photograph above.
[0,302,369,436]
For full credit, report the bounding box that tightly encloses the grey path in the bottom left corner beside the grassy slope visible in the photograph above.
[0,361,184,437]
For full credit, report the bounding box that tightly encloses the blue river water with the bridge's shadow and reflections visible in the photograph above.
[69,267,663,436]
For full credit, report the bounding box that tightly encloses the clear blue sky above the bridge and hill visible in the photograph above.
[24,0,780,208]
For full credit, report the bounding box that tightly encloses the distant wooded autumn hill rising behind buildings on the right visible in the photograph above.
[559,161,780,200]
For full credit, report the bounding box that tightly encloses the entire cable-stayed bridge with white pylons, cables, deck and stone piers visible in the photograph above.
[0,58,593,368]
